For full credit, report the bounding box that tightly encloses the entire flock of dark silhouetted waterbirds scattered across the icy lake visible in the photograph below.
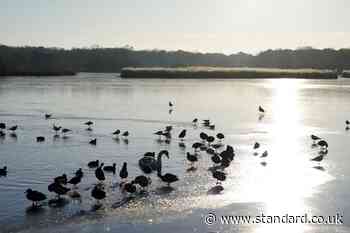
[0,102,332,208]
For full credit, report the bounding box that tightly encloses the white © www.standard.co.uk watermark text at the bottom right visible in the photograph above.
[203,213,344,225]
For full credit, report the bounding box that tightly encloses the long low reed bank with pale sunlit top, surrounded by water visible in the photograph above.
[120,67,337,79]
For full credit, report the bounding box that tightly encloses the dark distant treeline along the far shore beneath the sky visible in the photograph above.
[0,45,350,75]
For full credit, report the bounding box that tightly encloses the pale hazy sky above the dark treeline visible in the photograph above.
[0,0,350,54]
